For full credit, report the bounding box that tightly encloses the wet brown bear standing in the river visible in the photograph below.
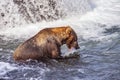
[13,26,79,61]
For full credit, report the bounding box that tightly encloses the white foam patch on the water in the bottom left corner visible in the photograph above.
[0,62,50,80]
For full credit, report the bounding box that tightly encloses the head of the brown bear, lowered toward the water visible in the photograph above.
[64,26,80,49]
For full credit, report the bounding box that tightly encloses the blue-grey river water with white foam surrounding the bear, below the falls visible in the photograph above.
[0,0,120,80]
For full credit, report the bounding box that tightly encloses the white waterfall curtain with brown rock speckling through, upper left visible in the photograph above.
[0,0,90,28]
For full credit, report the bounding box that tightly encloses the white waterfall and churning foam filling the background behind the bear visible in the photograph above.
[0,0,120,40]
